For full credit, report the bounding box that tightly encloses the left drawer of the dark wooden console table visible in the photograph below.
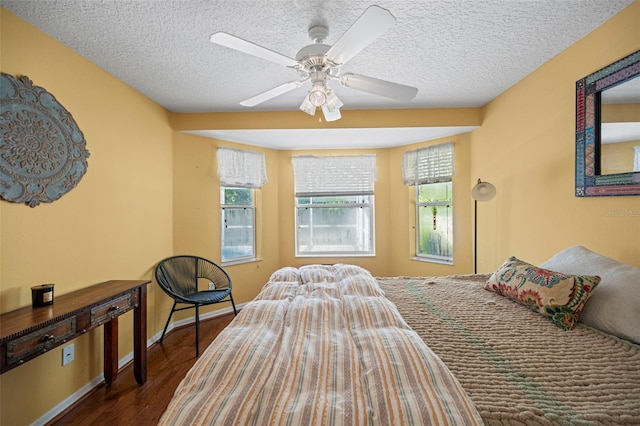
[6,316,76,365]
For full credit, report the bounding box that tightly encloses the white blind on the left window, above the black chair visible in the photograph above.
[217,147,267,188]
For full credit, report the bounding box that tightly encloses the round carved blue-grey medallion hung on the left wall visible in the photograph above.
[0,73,89,207]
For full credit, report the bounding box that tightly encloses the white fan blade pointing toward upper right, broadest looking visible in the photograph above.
[325,6,396,66]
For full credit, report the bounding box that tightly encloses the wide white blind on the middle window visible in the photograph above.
[291,154,377,197]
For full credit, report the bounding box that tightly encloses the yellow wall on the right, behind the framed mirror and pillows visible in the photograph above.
[471,1,640,272]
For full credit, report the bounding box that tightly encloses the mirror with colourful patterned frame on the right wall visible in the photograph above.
[576,51,640,197]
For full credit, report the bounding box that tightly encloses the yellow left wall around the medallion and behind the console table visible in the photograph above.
[0,9,173,425]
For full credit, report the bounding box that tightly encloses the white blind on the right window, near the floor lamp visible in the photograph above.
[402,142,453,185]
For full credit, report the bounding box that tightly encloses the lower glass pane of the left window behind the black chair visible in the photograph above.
[222,207,255,261]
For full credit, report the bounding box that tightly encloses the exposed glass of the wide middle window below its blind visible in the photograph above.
[297,195,373,255]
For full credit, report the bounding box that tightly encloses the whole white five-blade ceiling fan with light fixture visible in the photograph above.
[210,6,418,121]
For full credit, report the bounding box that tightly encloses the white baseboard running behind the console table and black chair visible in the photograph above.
[32,303,245,426]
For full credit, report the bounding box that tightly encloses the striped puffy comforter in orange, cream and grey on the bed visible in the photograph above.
[160,265,482,425]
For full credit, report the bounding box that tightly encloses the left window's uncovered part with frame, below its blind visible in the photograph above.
[220,187,256,262]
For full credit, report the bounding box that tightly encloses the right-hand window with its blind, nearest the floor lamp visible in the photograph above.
[402,143,453,263]
